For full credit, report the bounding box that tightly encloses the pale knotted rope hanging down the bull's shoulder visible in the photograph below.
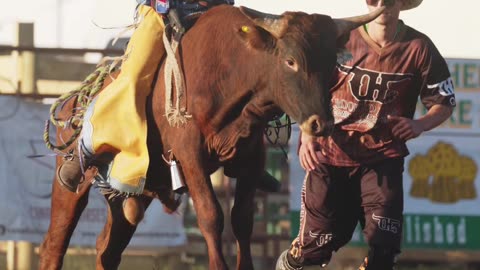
[163,28,192,127]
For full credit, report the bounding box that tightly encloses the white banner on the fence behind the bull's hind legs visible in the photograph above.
[0,96,186,247]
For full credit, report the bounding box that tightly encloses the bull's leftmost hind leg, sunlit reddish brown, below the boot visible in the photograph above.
[39,172,91,270]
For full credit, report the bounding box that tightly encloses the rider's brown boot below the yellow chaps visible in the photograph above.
[57,150,87,192]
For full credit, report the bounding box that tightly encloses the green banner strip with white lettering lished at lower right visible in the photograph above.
[291,211,480,250]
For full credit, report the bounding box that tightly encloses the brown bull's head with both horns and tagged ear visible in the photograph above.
[240,7,384,136]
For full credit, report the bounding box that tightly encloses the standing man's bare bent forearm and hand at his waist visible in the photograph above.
[388,104,453,141]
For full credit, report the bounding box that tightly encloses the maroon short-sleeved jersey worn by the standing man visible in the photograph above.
[318,23,455,166]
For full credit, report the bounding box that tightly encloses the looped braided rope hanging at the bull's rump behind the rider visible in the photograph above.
[43,64,111,152]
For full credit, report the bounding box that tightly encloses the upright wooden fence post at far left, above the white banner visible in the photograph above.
[14,23,36,94]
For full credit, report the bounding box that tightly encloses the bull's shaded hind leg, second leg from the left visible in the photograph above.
[96,196,152,270]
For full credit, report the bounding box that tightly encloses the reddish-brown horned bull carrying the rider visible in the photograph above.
[40,5,383,269]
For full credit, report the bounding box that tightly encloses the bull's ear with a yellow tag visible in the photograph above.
[238,26,277,52]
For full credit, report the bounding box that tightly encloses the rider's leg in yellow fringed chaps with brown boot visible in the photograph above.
[58,5,164,193]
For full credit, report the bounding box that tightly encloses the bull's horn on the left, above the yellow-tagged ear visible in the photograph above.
[240,6,288,38]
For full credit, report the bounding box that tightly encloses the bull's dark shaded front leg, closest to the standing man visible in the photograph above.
[231,176,256,270]
